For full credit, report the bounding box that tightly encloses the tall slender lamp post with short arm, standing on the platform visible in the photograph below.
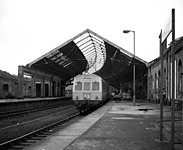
[123,30,135,106]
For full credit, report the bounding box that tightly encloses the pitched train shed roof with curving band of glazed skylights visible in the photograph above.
[27,29,147,87]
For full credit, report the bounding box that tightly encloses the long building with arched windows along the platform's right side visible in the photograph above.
[147,37,183,104]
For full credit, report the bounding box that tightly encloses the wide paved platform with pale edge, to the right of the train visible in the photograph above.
[29,101,182,150]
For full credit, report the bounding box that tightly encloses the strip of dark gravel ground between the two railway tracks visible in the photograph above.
[0,106,78,143]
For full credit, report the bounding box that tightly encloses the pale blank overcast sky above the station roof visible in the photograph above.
[0,0,183,74]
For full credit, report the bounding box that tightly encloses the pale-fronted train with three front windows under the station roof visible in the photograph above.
[72,74,110,113]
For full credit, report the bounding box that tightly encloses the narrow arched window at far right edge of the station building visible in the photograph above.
[178,60,183,92]
